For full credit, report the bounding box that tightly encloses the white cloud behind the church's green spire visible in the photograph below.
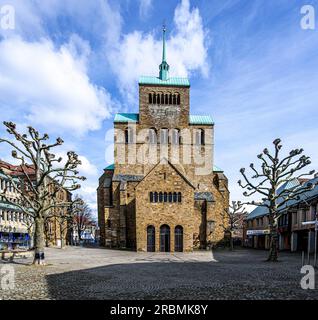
[108,0,209,104]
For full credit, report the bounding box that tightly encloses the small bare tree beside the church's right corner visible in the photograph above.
[222,201,248,250]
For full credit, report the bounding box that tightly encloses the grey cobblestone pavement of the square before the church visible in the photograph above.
[0,247,318,299]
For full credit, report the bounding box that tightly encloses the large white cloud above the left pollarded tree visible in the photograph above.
[0,36,113,134]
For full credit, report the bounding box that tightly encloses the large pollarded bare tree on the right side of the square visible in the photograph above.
[238,139,315,261]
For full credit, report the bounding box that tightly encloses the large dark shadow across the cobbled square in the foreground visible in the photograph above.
[46,251,317,300]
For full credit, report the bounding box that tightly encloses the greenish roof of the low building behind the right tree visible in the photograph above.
[247,177,318,220]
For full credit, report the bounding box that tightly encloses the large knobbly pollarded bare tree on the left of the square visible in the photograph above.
[0,122,85,264]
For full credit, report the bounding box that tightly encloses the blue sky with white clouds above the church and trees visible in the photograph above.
[0,0,318,214]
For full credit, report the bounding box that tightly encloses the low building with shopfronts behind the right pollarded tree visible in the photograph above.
[244,177,318,251]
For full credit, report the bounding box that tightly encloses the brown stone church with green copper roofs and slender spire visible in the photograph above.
[97,28,229,252]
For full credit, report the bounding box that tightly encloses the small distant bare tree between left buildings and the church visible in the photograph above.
[73,196,94,244]
